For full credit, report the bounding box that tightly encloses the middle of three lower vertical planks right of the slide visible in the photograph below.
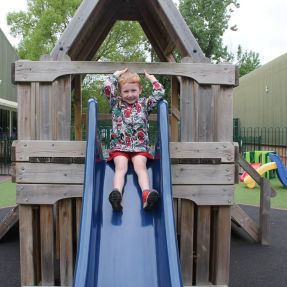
[195,206,211,285]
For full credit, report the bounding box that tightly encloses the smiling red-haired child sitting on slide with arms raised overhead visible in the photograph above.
[104,68,165,211]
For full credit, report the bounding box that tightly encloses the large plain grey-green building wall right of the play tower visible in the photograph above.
[234,53,287,127]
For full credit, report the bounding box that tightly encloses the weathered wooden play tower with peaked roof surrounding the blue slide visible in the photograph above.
[13,0,260,286]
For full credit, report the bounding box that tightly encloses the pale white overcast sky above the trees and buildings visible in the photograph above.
[0,0,287,65]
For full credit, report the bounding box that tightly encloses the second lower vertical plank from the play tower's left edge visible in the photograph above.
[39,205,55,285]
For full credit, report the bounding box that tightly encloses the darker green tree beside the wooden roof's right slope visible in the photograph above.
[179,0,240,62]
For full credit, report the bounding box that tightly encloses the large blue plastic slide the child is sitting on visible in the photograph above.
[73,100,183,287]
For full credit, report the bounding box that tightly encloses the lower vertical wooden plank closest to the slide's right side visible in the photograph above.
[180,200,194,285]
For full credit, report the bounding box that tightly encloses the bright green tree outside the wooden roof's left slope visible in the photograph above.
[7,0,82,60]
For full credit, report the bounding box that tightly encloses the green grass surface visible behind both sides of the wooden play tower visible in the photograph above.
[0,178,287,209]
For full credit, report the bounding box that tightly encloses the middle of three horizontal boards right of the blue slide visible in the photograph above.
[172,164,234,185]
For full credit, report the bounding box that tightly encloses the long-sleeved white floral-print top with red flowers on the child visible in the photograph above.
[104,74,165,153]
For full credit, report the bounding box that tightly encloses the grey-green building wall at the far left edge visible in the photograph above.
[0,29,17,102]
